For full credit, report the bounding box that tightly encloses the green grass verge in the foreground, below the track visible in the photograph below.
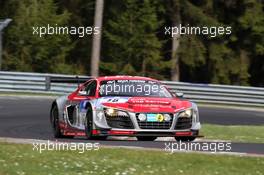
[0,143,264,175]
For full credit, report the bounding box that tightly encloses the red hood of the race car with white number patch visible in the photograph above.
[100,97,192,113]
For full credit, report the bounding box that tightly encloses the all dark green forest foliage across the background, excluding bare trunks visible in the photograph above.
[0,0,264,86]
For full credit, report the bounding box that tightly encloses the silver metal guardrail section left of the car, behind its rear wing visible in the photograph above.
[0,71,90,94]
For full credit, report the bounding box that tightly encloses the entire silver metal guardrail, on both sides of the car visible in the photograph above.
[0,71,264,107]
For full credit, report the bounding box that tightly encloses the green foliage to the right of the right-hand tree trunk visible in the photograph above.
[168,0,264,85]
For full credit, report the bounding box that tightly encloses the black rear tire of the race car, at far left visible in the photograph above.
[50,104,74,138]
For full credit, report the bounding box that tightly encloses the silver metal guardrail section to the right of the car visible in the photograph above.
[163,81,264,108]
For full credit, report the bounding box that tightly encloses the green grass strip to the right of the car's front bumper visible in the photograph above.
[201,124,264,143]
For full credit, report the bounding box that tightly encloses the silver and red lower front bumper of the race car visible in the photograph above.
[93,108,201,137]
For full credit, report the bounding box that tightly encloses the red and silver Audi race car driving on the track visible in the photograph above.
[50,76,201,141]
